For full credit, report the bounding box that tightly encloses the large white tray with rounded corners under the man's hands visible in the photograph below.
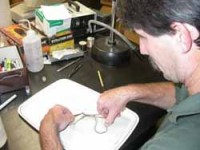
[18,79,139,150]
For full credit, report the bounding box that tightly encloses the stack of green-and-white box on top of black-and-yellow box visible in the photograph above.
[35,8,74,54]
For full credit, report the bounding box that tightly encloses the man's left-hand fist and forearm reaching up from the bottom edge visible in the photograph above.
[39,105,74,150]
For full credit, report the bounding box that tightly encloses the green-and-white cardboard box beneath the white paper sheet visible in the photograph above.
[35,9,71,37]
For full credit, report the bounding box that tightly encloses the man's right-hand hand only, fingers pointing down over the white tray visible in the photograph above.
[97,87,127,125]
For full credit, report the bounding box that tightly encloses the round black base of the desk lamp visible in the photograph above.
[91,37,130,66]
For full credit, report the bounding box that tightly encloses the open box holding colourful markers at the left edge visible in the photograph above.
[0,46,29,94]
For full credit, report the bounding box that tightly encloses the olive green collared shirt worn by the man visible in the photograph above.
[141,86,200,150]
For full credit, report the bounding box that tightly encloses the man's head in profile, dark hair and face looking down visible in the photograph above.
[118,0,200,82]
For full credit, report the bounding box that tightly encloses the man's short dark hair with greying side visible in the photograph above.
[117,0,200,45]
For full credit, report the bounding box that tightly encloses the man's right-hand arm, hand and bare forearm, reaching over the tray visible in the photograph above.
[97,82,176,125]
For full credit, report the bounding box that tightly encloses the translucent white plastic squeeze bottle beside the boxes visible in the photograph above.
[23,30,44,72]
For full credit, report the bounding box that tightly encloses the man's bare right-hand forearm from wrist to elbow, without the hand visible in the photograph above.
[122,82,176,109]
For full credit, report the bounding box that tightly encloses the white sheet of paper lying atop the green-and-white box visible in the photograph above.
[41,4,71,20]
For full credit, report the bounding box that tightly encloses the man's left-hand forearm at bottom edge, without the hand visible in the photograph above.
[40,115,63,150]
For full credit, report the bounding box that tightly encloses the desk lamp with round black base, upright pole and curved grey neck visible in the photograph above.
[88,0,136,66]
